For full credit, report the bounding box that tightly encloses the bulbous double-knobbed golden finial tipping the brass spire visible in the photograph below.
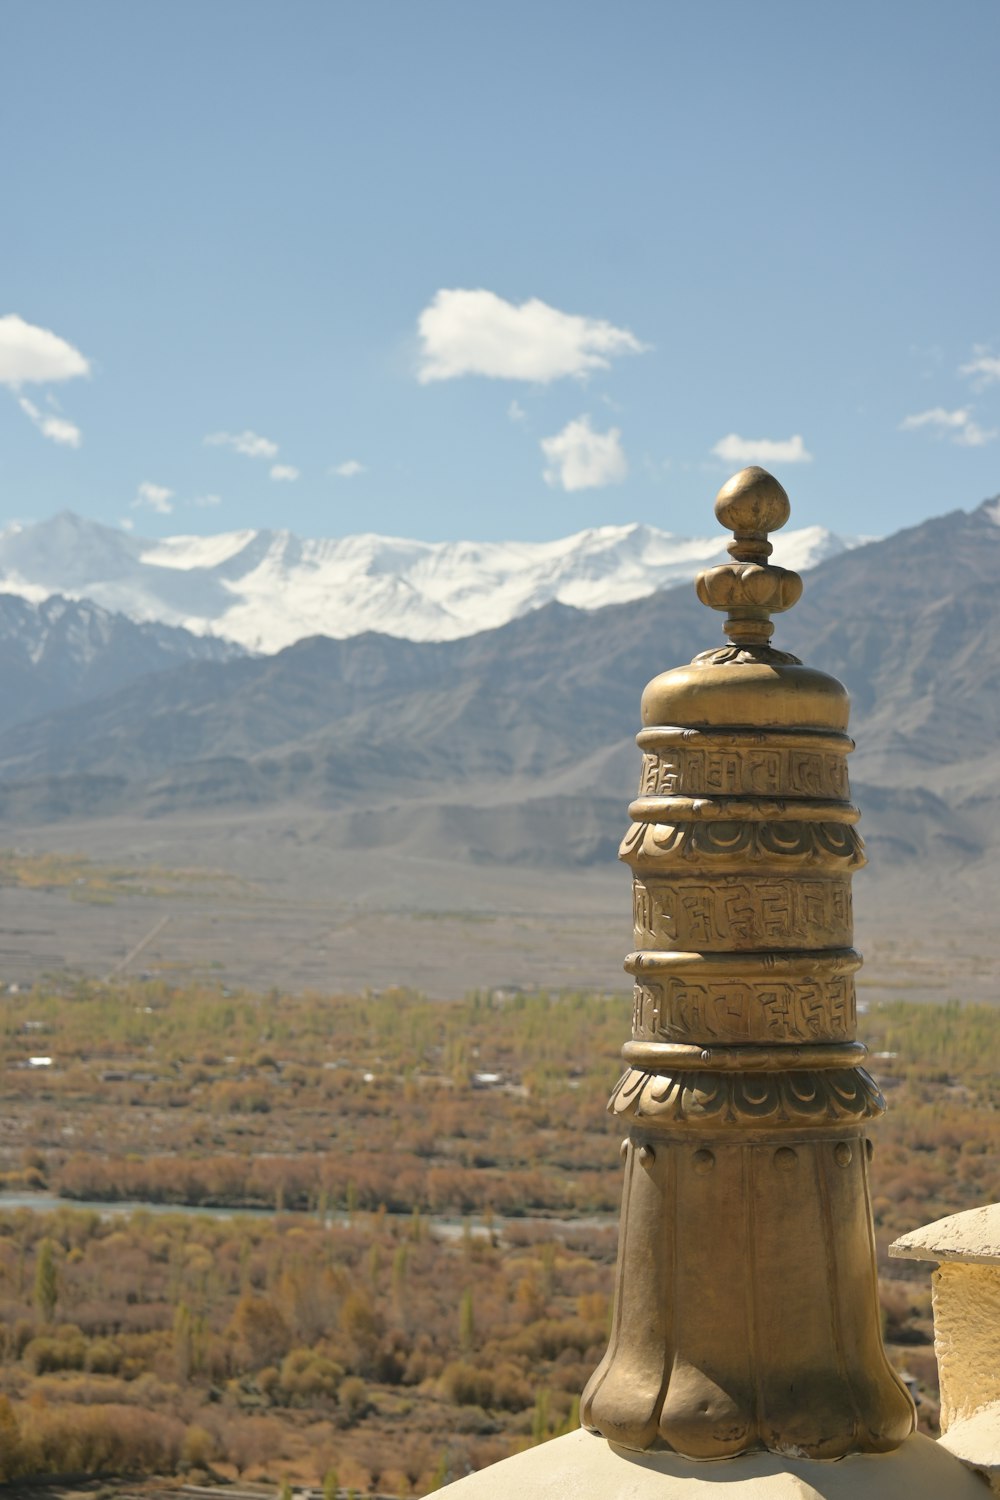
[696,468,802,648]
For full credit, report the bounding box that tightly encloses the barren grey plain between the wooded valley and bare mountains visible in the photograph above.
[0,807,1000,1004]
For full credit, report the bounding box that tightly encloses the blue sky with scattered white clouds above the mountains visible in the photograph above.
[0,0,1000,539]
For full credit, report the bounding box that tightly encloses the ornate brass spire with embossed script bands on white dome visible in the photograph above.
[582,468,913,1458]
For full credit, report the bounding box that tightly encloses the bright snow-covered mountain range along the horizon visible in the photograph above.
[0,512,868,653]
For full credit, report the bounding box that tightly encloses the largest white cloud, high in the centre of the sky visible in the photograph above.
[417,288,646,386]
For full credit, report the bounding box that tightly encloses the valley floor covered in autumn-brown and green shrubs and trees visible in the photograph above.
[0,984,1000,1500]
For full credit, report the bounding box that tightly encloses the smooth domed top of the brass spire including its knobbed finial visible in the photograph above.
[643,468,849,732]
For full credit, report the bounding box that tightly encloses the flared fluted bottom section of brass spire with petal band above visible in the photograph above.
[580,1098,915,1460]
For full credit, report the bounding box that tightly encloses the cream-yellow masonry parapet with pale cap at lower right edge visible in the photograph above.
[889,1203,1000,1494]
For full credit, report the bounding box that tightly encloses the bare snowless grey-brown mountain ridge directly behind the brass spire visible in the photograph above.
[0,501,1000,891]
